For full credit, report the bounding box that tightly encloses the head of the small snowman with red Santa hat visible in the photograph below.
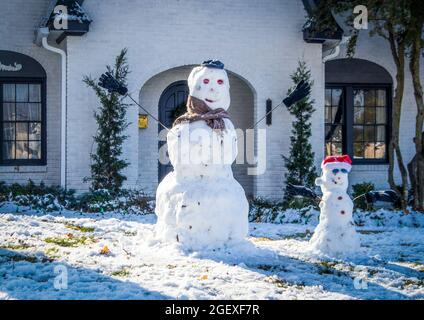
[315,155,352,191]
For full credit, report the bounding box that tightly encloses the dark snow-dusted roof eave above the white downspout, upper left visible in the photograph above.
[45,0,92,43]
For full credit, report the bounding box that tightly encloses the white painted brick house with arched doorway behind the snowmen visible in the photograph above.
[0,0,416,198]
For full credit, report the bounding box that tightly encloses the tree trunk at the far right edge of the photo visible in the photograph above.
[409,31,424,212]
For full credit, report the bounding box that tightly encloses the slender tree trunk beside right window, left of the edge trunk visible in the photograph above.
[388,27,408,212]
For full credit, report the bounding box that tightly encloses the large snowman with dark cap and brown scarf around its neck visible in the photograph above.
[155,60,248,249]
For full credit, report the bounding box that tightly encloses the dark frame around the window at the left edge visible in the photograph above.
[0,77,47,166]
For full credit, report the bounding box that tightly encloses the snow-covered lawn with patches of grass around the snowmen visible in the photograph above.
[0,207,424,299]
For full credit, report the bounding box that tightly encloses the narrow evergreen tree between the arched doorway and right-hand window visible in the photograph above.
[283,61,317,206]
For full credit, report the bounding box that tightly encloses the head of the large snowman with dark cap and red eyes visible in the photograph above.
[187,60,230,110]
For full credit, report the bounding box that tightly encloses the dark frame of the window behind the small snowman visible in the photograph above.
[324,83,393,165]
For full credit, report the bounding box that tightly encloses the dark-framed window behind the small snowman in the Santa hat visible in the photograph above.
[325,85,390,163]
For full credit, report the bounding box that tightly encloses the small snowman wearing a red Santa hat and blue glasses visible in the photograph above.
[310,155,360,256]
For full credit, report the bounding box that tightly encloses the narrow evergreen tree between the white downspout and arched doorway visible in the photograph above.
[83,49,129,194]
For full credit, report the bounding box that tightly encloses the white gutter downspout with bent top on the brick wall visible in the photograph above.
[36,27,67,189]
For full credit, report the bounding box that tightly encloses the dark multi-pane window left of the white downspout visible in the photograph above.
[0,79,45,165]
